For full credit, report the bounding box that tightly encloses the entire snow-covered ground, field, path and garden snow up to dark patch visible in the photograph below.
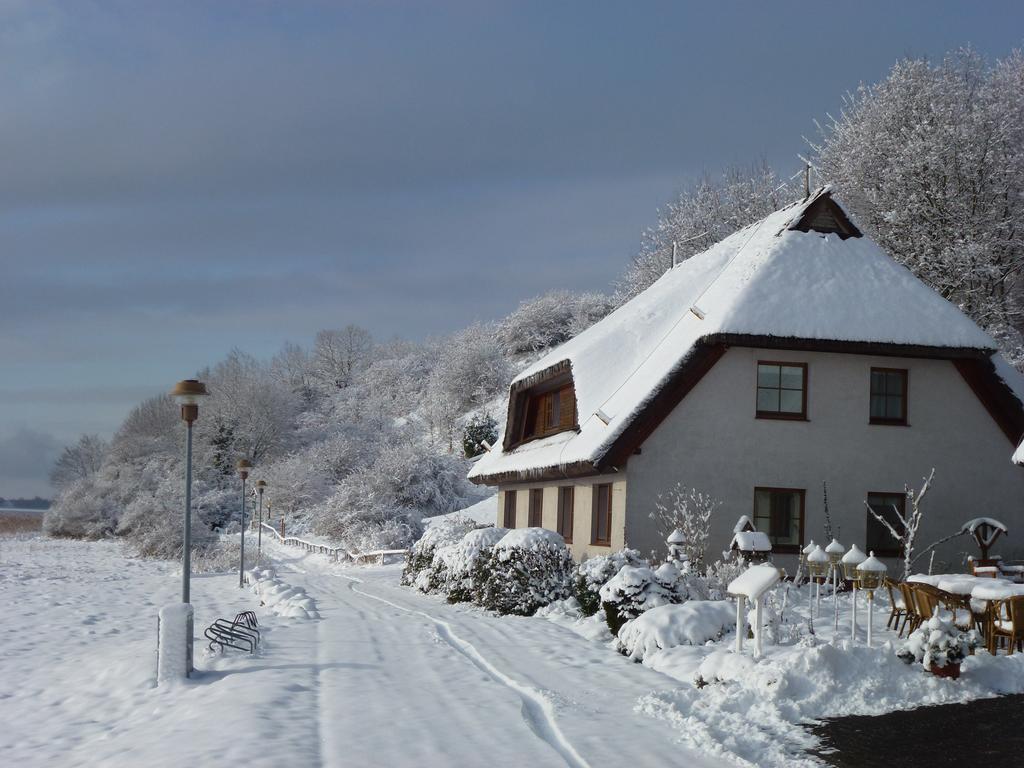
[8,537,1024,766]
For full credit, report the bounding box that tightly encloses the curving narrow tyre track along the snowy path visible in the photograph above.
[340,573,590,768]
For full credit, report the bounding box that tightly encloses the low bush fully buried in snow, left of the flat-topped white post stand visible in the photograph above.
[615,600,735,662]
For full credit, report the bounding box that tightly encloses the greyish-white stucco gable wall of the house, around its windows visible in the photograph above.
[626,347,1024,575]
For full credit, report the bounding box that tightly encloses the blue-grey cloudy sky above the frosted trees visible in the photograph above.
[0,0,1024,497]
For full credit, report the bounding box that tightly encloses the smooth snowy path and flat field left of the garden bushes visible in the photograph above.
[0,538,722,767]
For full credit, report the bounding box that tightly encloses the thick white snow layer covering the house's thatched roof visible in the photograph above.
[469,188,999,478]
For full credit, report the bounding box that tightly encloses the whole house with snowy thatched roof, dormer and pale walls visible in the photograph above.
[469,188,1024,564]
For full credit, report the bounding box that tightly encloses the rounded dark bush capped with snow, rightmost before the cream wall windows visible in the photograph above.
[474,528,574,616]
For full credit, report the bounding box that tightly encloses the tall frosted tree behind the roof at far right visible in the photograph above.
[810,49,1024,360]
